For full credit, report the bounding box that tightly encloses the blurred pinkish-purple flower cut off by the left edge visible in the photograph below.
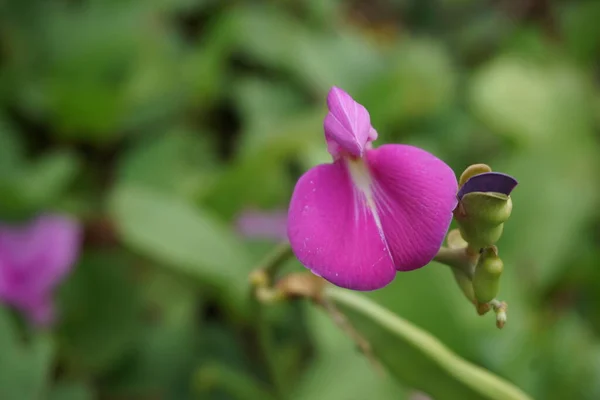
[0,215,81,325]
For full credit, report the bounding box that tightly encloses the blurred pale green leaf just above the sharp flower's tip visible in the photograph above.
[231,5,384,95]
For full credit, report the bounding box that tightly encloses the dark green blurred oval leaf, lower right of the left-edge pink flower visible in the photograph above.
[58,252,141,372]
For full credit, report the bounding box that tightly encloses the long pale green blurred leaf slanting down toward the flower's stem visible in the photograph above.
[110,185,250,316]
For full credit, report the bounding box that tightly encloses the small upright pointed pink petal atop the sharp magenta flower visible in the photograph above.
[323,87,370,157]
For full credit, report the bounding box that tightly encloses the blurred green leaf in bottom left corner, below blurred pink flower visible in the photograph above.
[0,308,53,400]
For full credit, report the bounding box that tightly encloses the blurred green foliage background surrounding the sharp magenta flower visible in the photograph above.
[0,0,600,400]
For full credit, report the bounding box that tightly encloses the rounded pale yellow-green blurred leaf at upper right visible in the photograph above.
[470,55,593,146]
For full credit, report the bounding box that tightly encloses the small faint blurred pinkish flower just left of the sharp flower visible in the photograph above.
[236,210,287,241]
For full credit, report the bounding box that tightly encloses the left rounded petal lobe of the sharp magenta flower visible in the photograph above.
[288,159,396,290]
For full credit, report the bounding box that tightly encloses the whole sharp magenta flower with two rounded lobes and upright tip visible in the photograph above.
[288,87,458,291]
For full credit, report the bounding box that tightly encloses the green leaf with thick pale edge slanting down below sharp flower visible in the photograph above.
[325,288,530,400]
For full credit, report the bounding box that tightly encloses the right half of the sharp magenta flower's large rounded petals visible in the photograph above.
[367,144,458,271]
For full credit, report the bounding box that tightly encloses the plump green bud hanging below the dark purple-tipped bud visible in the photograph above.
[473,246,504,303]
